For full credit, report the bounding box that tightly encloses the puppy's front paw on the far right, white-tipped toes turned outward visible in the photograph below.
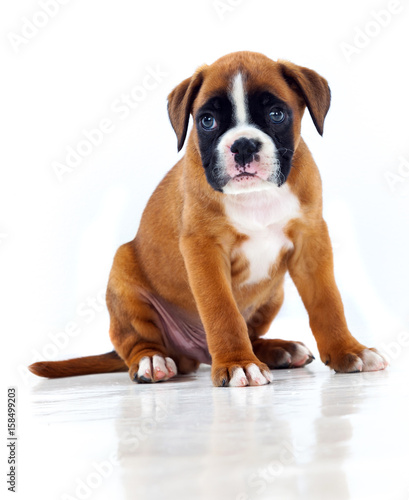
[323,346,389,373]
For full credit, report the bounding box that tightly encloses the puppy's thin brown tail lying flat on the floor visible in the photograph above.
[28,351,128,378]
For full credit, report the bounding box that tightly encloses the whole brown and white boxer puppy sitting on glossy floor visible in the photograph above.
[30,52,387,386]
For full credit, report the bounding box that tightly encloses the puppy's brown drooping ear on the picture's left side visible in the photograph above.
[168,67,203,151]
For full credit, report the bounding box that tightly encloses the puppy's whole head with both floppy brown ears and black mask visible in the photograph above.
[168,52,330,194]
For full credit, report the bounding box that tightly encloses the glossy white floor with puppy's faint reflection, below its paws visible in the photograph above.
[19,360,409,500]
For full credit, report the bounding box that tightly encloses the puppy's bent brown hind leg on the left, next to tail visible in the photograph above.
[107,243,199,383]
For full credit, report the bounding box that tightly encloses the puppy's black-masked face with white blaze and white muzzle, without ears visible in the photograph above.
[194,71,294,194]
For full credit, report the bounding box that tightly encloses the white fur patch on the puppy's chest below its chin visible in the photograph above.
[225,184,300,285]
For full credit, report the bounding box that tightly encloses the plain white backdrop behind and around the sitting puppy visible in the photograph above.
[0,0,409,387]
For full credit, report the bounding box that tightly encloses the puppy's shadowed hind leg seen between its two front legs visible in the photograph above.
[247,288,315,369]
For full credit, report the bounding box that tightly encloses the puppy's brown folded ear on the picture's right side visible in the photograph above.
[279,61,331,135]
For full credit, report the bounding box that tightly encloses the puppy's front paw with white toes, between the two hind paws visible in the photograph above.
[212,361,273,387]
